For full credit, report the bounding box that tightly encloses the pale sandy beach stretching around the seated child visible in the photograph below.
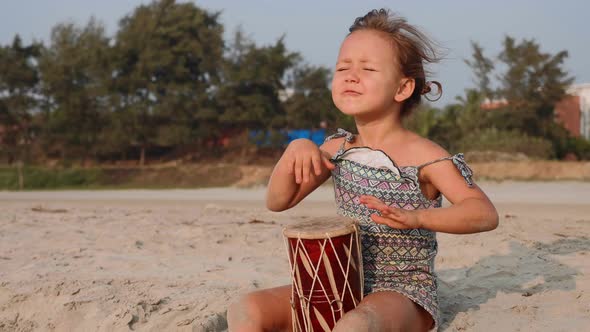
[0,182,590,331]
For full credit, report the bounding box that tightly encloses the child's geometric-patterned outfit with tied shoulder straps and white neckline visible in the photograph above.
[326,129,472,330]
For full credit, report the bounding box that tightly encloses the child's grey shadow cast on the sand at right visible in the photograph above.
[438,237,590,330]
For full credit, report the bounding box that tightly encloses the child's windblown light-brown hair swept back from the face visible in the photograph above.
[349,9,442,117]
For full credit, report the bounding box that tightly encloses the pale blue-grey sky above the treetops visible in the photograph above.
[0,0,590,107]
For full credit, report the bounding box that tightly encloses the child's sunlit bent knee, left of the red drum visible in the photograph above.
[227,294,262,332]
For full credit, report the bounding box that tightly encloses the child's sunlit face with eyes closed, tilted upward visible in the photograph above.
[332,30,402,116]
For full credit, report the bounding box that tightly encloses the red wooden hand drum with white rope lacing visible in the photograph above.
[283,217,363,332]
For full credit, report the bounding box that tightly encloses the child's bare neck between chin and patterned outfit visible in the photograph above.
[355,112,406,148]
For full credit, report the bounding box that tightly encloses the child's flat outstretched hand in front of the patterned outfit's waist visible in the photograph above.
[360,195,422,229]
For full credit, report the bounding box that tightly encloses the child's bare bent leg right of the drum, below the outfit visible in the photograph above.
[333,291,434,332]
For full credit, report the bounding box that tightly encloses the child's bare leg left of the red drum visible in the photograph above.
[227,285,292,332]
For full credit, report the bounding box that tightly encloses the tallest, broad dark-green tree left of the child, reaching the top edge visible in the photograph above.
[113,0,224,163]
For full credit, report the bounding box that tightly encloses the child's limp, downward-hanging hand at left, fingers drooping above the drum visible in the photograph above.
[284,139,335,184]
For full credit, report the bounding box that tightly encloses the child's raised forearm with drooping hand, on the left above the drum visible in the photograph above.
[266,139,339,212]
